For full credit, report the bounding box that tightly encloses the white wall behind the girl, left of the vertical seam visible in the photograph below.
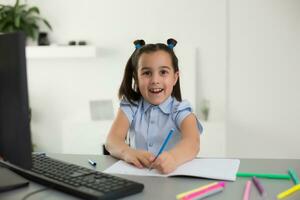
[22,0,226,155]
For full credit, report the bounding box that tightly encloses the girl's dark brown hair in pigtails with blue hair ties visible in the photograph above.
[118,39,182,104]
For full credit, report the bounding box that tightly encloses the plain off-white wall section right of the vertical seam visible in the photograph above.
[227,0,300,158]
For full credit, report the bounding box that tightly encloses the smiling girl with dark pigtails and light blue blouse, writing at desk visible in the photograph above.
[105,39,202,173]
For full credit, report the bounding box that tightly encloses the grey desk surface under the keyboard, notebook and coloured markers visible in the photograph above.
[0,154,300,200]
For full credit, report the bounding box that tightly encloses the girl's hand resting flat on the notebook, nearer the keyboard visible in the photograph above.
[122,148,154,169]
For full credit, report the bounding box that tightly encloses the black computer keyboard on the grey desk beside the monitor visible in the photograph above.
[4,154,144,199]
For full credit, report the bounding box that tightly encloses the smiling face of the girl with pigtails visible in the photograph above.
[137,50,179,105]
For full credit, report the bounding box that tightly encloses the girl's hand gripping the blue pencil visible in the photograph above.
[152,151,177,174]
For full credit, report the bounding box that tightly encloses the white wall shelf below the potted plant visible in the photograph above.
[26,45,96,59]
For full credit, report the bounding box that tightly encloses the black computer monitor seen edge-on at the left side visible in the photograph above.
[0,32,32,169]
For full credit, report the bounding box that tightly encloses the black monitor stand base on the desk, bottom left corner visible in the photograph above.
[0,165,29,192]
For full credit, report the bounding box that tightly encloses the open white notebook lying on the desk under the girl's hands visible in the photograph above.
[104,158,240,181]
